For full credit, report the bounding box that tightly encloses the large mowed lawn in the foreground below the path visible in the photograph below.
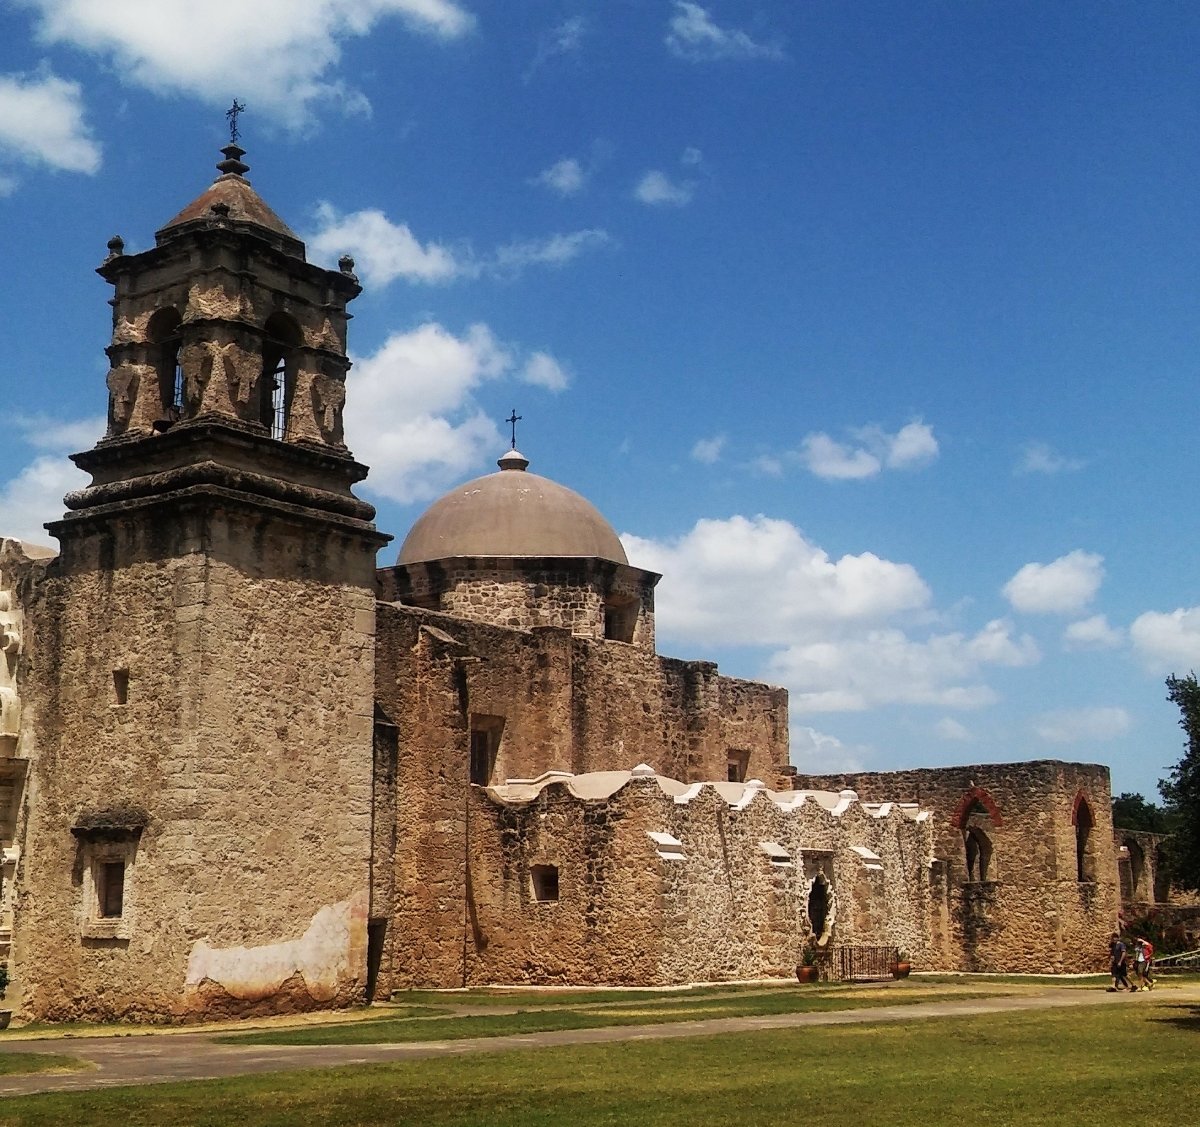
[0,990,1200,1127]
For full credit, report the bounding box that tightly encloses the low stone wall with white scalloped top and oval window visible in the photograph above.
[398,773,931,985]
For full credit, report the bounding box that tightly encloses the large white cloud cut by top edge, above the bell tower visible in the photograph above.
[24,0,475,127]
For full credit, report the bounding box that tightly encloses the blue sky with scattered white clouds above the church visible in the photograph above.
[0,0,1200,797]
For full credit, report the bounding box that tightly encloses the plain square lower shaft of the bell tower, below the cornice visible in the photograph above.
[13,498,374,1019]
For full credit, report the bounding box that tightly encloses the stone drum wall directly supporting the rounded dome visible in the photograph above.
[379,556,659,653]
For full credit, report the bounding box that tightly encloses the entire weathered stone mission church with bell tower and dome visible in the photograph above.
[0,146,1118,1019]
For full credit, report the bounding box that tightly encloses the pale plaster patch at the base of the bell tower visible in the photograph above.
[185,895,366,1002]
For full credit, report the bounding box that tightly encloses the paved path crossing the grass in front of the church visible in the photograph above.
[0,984,1185,1096]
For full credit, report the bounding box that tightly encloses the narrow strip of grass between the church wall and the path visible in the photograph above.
[220,985,996,1045]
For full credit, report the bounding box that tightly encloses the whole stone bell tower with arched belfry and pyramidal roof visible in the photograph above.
[13,144,390,1018]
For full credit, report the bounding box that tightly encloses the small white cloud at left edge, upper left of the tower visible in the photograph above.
[0,73,101,174]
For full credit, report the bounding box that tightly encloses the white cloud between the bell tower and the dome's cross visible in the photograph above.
[346,322,566,503]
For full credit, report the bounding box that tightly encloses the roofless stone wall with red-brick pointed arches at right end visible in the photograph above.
[793,761,1120,972]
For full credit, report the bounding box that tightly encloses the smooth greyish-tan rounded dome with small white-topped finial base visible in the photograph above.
[397,450,629,564]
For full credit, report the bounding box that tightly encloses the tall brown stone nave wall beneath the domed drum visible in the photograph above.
[373,604,787,990]
